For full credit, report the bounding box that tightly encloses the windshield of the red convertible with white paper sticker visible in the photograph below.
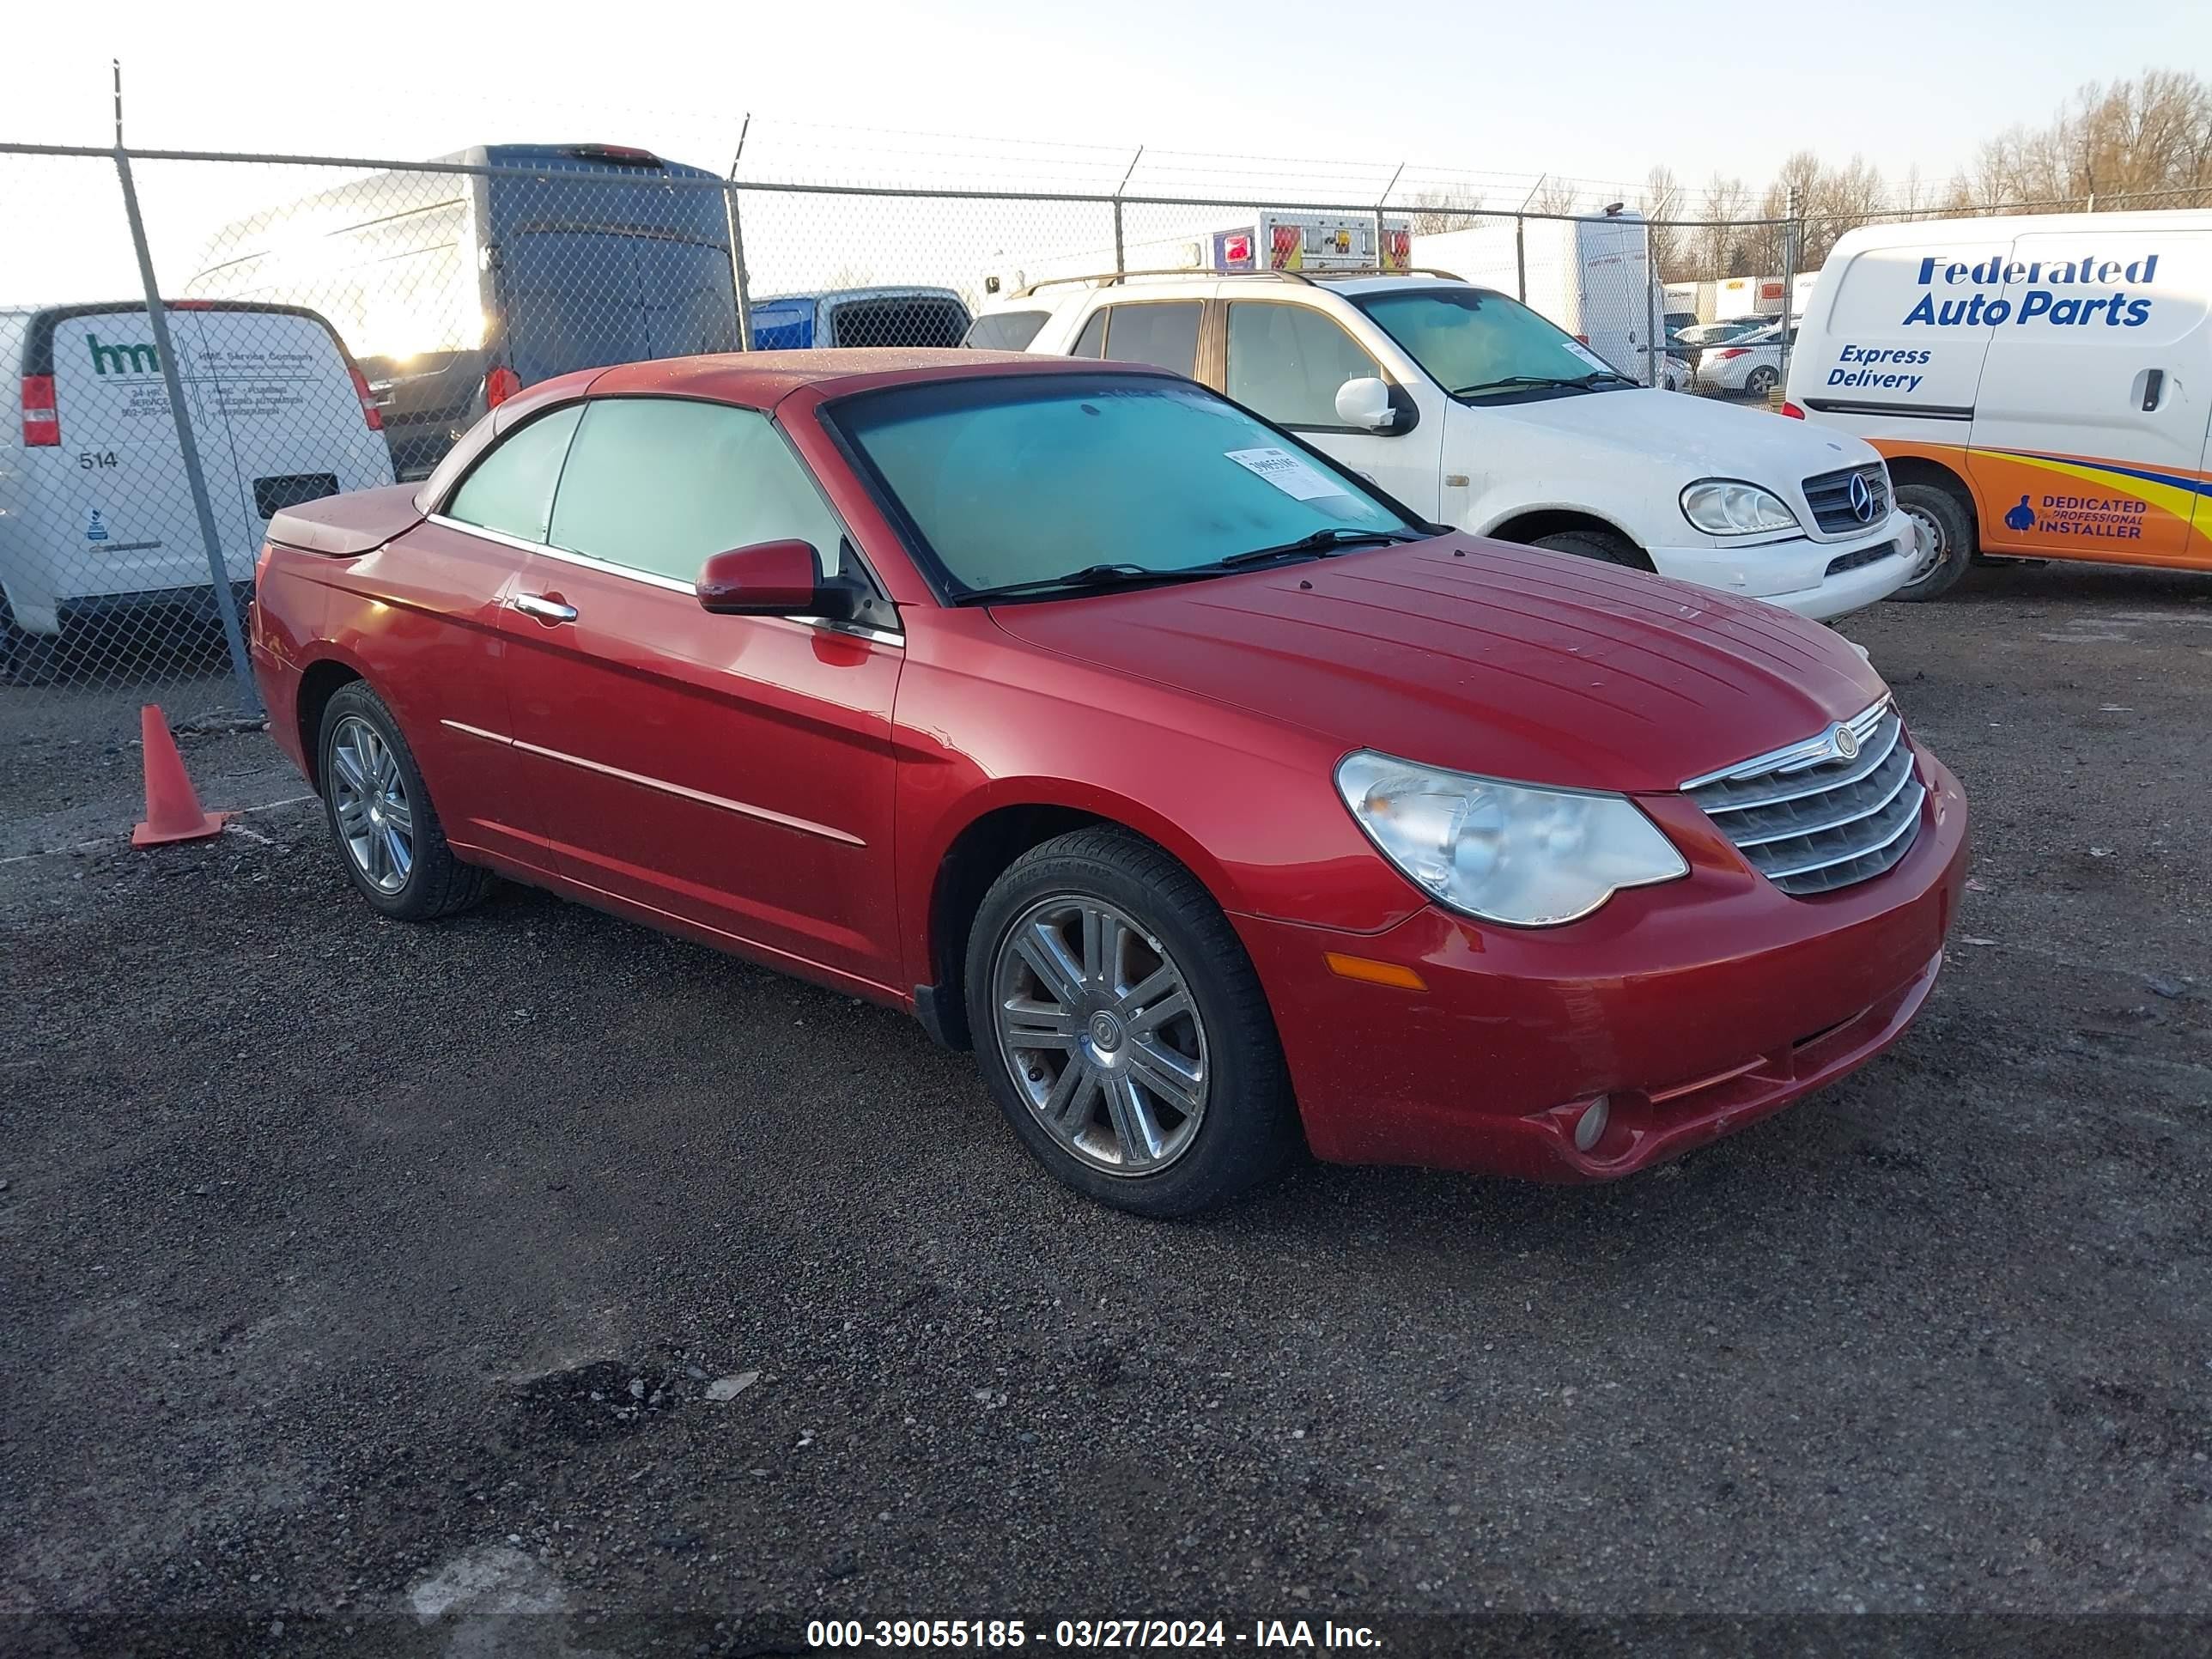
[832,374,1427,599]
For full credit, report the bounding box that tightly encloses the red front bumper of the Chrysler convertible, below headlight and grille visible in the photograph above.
[1237,750,1966,1182]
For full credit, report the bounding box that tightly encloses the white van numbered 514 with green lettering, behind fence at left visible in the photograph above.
[0,301,392,681]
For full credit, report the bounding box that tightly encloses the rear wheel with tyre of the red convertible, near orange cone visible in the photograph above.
[316,679,491,922]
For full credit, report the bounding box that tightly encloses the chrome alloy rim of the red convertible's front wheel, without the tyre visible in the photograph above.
[991,894,1212,1175]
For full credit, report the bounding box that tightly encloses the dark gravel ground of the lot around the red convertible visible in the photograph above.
[0,568,2212,1655]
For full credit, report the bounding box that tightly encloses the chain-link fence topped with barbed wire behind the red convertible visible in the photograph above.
[0,143,2194,732]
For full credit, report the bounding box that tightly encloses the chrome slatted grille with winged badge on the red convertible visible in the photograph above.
[1681,699,1927,898]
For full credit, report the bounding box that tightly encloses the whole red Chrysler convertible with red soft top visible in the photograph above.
[254,352,1966,1214]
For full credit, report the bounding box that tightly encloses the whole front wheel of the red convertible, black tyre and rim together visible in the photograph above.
[967,827,1301,1217]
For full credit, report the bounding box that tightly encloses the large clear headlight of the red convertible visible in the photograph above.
[1336,750,1690,927]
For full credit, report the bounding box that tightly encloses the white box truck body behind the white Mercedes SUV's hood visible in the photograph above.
[1413,212,1666,385]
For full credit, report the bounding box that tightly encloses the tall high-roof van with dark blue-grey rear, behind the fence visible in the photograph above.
[185,143,738,477]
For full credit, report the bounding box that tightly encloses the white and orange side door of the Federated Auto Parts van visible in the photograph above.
[1969,219,2212,566]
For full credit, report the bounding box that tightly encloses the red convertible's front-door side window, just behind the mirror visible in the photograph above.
[546,398,842,584]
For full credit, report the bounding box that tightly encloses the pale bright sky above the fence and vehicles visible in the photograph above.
[0,0,2212,303]
